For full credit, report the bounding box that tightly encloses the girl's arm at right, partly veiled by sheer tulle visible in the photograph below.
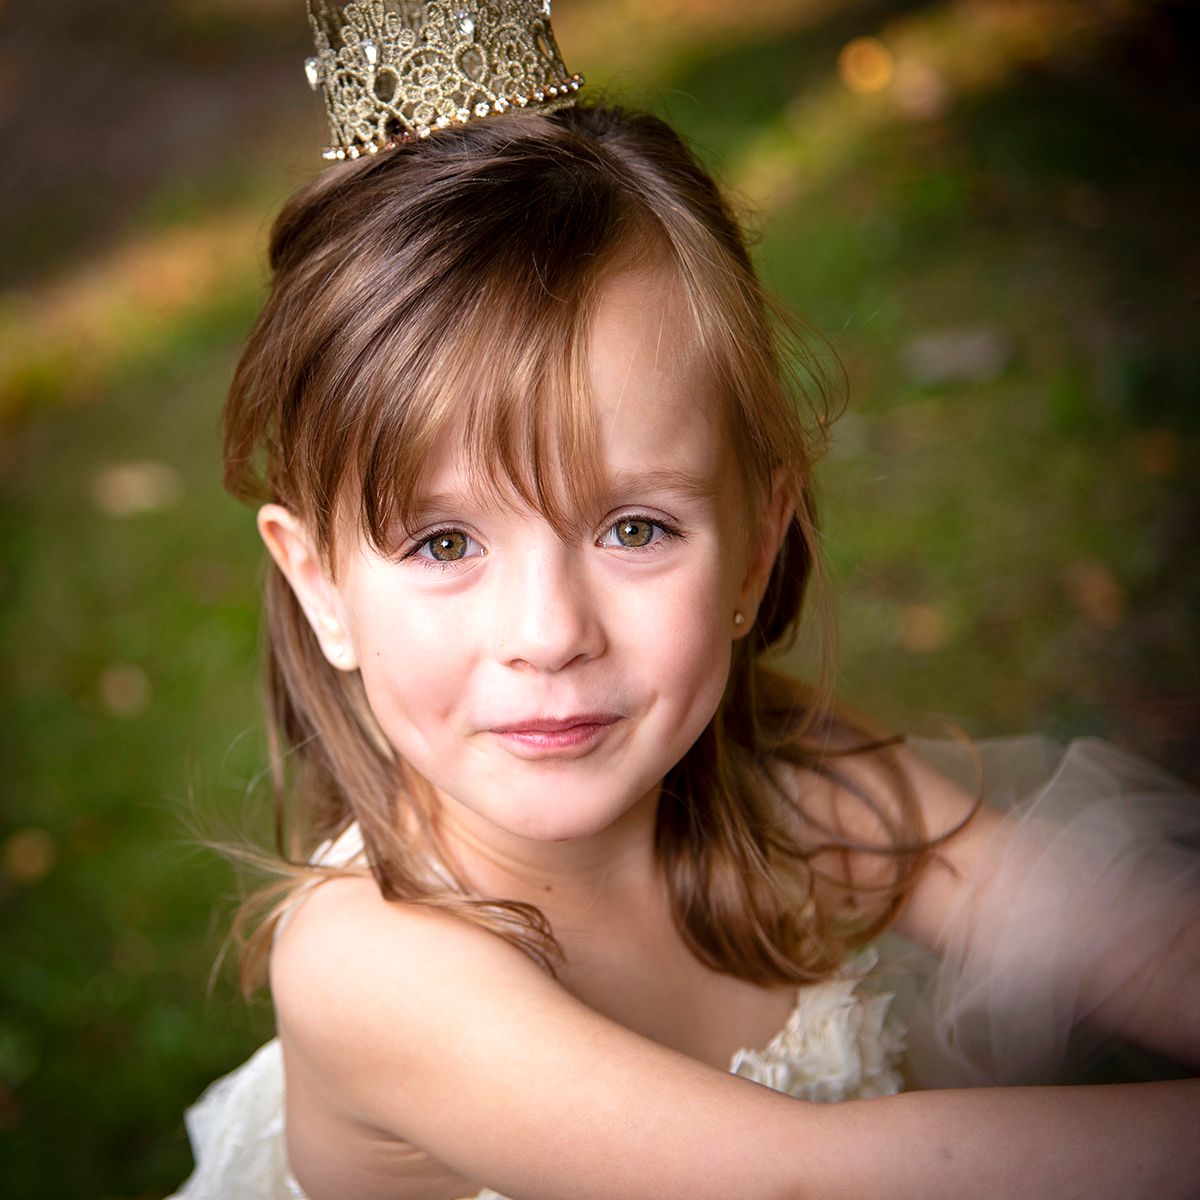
[876,751,1200,1068]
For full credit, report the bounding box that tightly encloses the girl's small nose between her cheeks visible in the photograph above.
[496,530,605,671]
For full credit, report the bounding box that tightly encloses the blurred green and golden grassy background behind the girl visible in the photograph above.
[0,0,1200,1198]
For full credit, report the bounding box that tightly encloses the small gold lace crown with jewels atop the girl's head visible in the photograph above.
[305,0,583,160]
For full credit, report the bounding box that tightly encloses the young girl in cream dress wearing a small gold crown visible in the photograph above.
[174,0,1200,1200]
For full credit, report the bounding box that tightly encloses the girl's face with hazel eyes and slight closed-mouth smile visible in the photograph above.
[262,272,790,842]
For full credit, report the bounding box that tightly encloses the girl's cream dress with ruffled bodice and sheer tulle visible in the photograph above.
[169,737,1200,1200]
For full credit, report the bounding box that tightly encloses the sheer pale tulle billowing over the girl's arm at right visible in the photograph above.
[890,737,1200,1087]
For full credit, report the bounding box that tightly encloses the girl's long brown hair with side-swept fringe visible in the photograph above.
[224,106,924,986]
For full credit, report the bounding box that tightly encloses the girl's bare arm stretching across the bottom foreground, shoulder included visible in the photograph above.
[272,881,1200,1200]
